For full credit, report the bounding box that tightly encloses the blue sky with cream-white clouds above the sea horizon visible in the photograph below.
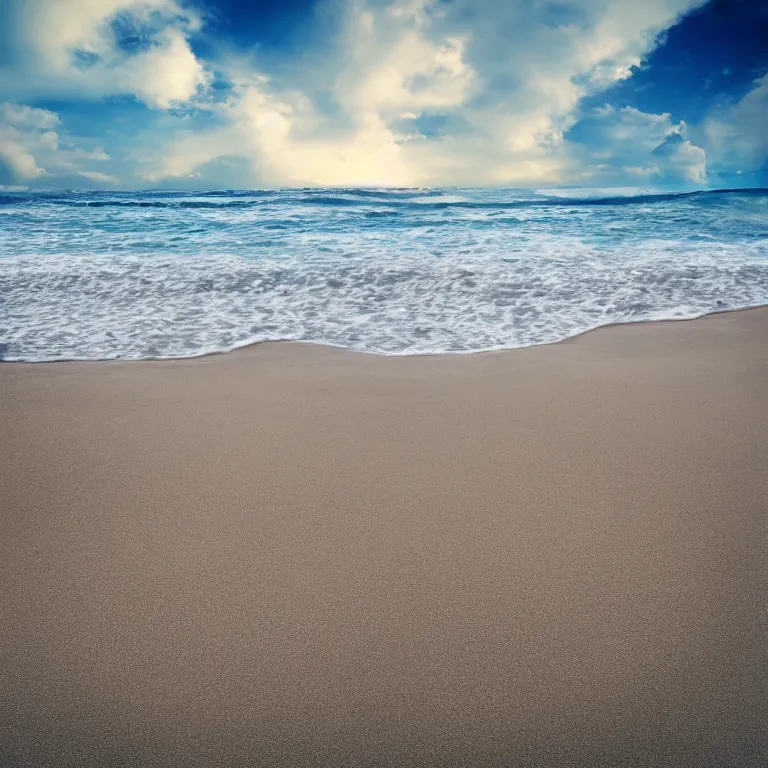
[0,0,768,189]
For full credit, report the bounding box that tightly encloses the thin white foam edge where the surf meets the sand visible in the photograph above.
[0,304,768,366]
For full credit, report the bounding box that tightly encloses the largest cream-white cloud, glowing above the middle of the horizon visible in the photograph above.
[138,0,700,185]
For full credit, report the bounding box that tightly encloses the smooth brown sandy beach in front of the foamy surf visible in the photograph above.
[0,310,768,768]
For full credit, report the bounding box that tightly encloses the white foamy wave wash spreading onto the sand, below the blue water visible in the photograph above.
[0,238,768,360]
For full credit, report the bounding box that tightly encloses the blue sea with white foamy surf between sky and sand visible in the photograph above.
[0,189,768,360]
